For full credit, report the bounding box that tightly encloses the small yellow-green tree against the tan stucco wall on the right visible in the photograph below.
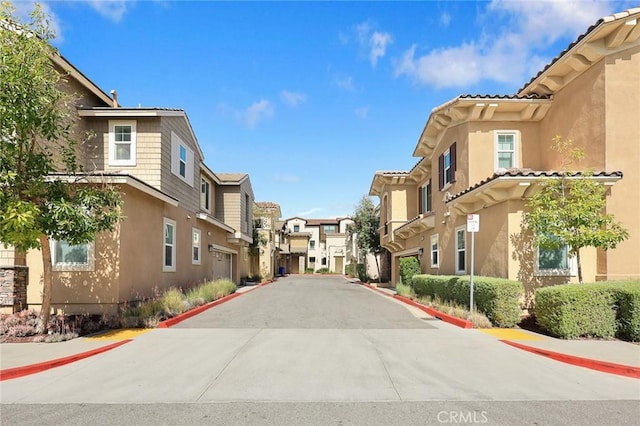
[525,136,629,283]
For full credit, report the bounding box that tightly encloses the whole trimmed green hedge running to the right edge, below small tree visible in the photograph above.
[535,280,640,341]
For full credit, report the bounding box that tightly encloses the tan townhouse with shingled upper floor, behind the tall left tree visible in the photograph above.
[0,48,254,314]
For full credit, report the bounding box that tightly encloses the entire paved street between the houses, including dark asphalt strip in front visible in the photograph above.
[0,276,640,425]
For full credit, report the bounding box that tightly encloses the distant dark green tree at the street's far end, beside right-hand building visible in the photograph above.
[347,195,384,276]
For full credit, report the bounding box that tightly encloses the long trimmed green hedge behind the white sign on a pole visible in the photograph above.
[413,275,524,327]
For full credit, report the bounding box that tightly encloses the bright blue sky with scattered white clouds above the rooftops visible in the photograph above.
[14,0,637,218]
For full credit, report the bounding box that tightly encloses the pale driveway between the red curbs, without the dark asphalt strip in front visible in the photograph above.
[0,275,640,420]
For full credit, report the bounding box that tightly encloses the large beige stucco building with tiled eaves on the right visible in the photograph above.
[370,8,640,297]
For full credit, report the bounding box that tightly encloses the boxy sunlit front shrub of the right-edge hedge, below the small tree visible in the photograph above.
[535,284,616,339]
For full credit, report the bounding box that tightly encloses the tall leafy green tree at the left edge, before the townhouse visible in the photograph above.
[0,2,121,332]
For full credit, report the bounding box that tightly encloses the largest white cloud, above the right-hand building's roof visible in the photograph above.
[395,0,611,88]
